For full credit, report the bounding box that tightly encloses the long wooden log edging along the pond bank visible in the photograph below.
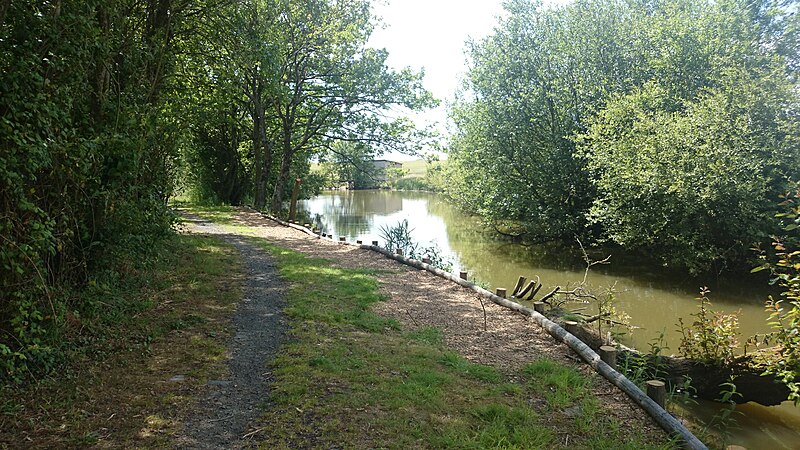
[245,208,708,450]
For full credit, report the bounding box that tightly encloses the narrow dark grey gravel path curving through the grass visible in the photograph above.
[180,217,287,449]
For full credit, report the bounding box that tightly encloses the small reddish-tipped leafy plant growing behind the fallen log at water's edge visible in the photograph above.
[678,288,739,366]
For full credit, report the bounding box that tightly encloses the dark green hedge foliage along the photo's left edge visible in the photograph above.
[0,0,202,380]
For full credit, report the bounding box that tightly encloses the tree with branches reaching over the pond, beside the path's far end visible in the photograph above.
[271,0,434,212]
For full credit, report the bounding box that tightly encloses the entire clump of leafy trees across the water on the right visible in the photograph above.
[447,0,800,273]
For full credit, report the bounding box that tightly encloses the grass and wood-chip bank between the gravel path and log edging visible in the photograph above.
[191,206,680,448]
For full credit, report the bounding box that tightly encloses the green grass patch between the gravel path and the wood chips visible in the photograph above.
[247,239,666,449]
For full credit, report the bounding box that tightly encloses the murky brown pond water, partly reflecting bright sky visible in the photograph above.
[299,191,800,449]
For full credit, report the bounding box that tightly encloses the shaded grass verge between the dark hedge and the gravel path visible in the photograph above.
[0,235,242,448]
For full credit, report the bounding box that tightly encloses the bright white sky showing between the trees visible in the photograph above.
[368,0,503,161]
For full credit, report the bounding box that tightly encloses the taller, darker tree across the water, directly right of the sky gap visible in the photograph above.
[447,0,646,241]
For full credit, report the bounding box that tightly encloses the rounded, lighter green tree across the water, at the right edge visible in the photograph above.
[579,1,800,273]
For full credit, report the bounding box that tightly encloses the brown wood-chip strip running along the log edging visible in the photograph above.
[212,209,663,442]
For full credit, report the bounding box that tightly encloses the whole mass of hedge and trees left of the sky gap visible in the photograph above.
[0,0,434,380]
